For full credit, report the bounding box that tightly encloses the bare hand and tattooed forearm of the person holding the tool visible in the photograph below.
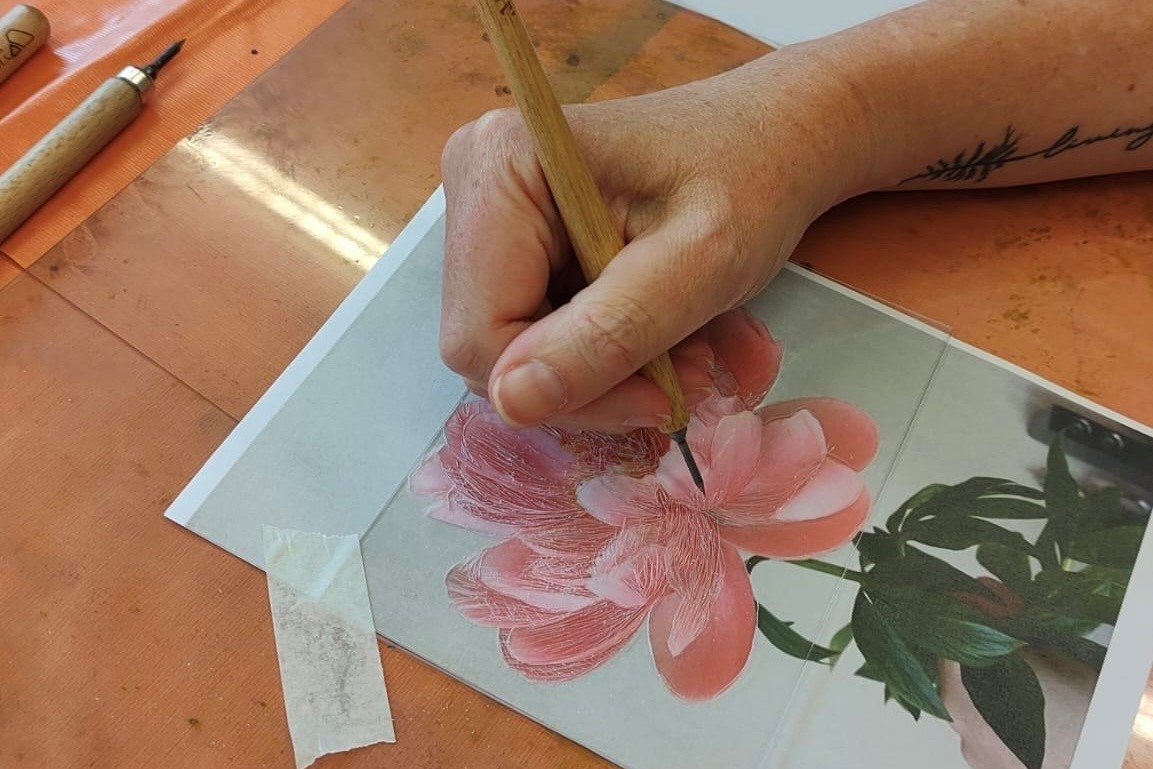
[442,0,1153,431]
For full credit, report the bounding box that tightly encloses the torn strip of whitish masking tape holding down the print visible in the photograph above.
[264,526,397,769]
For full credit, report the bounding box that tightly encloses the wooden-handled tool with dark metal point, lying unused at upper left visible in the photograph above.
[0,40,183,241]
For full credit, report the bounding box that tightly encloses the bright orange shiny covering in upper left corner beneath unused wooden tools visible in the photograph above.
[0,0,346,266]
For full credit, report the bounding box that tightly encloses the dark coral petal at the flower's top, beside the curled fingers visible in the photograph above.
[706,309,784,407]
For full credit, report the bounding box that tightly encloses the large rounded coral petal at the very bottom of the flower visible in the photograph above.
[649,546,756,702]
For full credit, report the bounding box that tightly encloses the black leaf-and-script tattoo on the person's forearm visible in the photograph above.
[900,123,1153,184]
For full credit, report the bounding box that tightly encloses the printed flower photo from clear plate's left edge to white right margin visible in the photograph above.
[355,271,1153,769]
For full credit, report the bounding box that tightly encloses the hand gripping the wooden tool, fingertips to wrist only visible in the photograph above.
[440,48,867,431]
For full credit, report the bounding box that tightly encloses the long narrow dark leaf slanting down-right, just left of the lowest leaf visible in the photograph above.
[853,590,950,721]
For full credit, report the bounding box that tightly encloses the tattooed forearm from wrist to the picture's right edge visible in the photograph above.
[737,0,1153,197]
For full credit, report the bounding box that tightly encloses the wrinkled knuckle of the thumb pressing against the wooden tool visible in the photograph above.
[575,299,653,372]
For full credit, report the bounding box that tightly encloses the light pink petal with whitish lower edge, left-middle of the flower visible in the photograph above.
[477,540,596,612]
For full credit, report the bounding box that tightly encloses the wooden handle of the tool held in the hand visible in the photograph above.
[476,0,688,432]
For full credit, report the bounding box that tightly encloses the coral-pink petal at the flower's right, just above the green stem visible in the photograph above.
[721,491,869,558]
